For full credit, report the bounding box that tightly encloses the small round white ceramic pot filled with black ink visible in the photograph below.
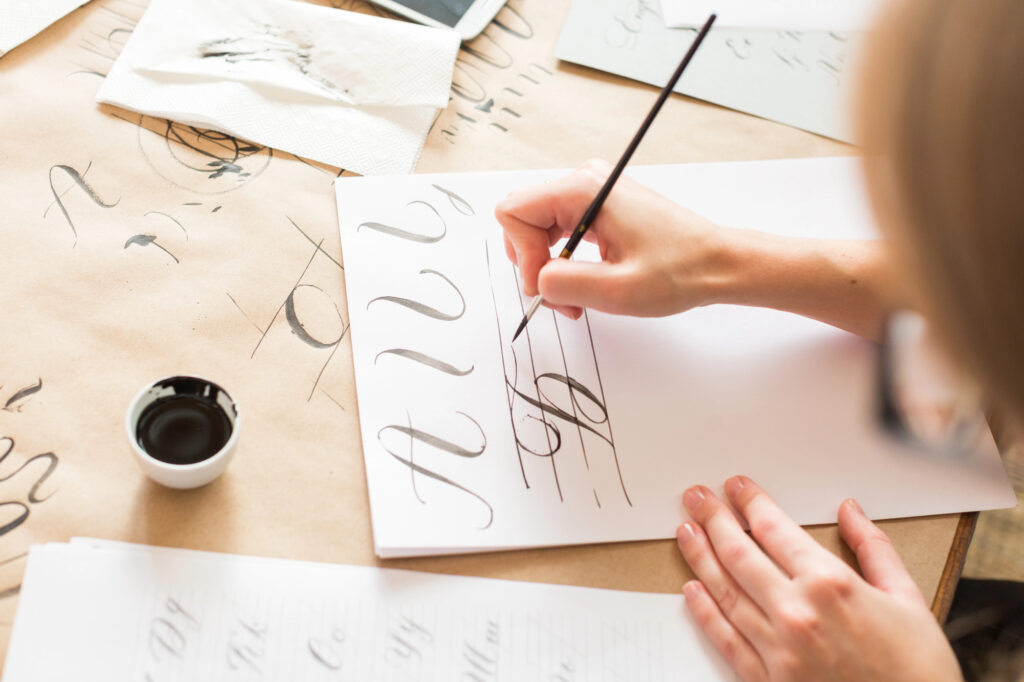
[125,376,242,488]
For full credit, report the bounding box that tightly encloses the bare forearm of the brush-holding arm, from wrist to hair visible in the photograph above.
[709,229,896,339]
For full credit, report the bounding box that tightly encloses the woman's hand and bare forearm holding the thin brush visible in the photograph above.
[495,161,905,338]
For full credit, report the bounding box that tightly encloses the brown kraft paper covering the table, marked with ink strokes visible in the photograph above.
[0,0,956,659]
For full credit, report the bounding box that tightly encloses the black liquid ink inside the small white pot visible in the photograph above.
[135,393,231,464]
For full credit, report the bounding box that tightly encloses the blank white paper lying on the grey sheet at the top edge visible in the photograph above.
[660,0,885,31]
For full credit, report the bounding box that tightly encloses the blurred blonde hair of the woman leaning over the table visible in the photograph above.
[856,0,1024,413]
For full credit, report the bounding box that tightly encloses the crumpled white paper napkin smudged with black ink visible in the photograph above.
[96,0,459,175]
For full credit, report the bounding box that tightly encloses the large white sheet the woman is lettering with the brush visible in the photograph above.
[336,159,1015,556]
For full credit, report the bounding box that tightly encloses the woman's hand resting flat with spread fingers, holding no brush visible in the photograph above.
[677,476,963,682]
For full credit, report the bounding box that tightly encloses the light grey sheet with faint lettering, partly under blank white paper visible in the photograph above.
[555,0,860,141]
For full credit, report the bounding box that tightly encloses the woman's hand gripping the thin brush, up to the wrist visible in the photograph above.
[495,161,730,317]
